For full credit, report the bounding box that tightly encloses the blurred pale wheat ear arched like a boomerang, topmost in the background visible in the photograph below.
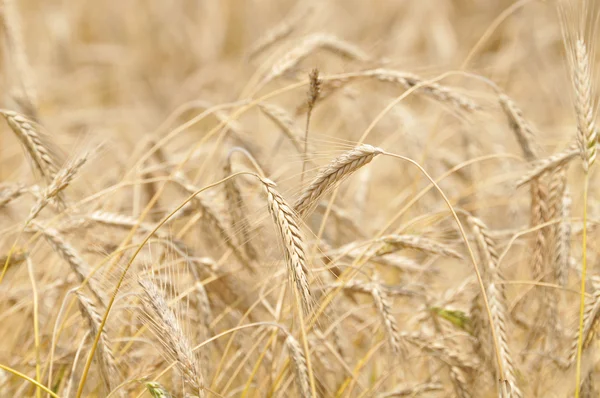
[260,33,369,86]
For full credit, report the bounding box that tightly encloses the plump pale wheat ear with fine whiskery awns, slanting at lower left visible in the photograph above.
[138,279,204,396]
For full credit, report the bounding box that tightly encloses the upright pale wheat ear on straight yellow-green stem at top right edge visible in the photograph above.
[573,39,598,170]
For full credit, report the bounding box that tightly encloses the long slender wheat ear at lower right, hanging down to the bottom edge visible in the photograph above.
[468,217,523,398]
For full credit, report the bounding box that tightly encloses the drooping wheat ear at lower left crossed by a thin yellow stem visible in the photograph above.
[76,291,119,392]
